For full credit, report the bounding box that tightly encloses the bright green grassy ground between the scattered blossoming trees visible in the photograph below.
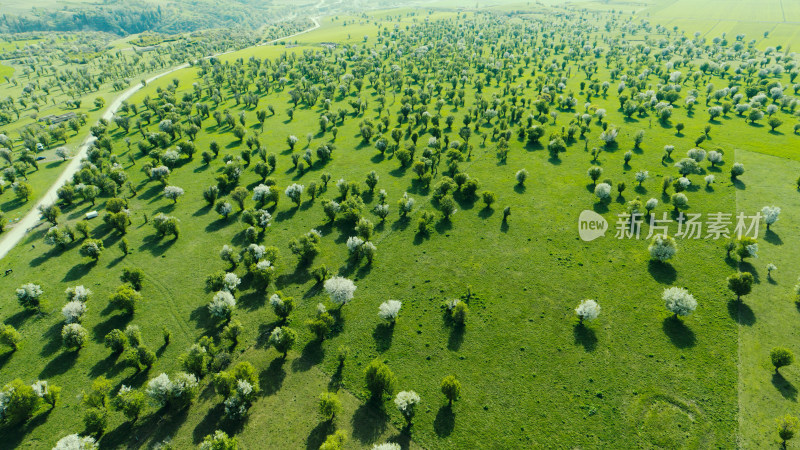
[0,1,800,448]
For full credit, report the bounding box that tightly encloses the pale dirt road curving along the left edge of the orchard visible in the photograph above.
[0,17,320,259]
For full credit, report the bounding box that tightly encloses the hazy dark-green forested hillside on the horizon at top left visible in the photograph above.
[0,0,298,36]
